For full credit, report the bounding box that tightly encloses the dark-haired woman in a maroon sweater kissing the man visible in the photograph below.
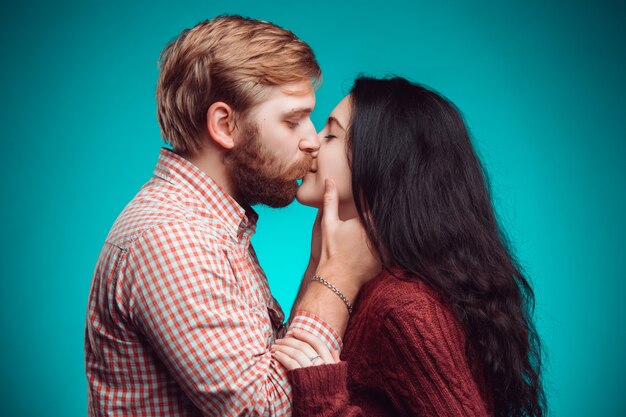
[273,77,545,417]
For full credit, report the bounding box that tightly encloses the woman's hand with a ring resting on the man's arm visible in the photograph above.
[271,329,340,370]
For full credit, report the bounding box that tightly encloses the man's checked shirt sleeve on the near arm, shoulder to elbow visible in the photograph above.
[127,222,291,416]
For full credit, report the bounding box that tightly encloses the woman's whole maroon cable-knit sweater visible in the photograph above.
[288,272,492,417]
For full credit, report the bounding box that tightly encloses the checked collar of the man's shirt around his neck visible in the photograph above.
[154,148,259,237]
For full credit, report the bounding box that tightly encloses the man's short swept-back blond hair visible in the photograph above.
[156,16,321,153]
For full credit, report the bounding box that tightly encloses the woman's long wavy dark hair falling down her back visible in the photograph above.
[347,77,545,417]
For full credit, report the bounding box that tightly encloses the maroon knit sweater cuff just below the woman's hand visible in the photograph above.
[287,362,365,417]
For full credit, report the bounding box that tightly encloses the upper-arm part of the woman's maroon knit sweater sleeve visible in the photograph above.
[381,296,489,417]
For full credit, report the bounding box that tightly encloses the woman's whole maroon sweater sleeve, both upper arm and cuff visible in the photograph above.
[287,296,489,417]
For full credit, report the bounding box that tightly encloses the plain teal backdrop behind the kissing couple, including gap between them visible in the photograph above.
[0,0,626,417]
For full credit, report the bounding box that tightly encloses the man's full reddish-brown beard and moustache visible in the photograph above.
[224,123,313,208]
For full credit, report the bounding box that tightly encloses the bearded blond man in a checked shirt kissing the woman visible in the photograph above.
[85,16,376,416]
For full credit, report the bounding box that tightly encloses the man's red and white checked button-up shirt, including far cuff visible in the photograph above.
[85,149,341,417]
